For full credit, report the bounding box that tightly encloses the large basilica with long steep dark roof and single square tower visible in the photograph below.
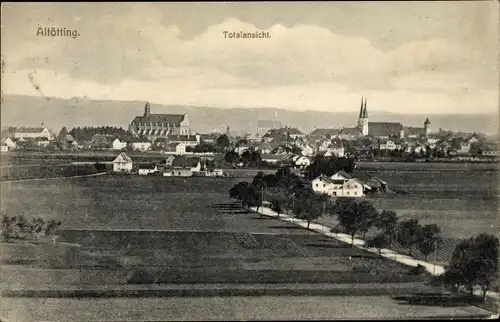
[129,103,191,141]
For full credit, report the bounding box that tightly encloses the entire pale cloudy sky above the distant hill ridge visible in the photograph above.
[1,1,500,115]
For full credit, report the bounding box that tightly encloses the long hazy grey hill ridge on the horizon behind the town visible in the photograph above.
[1,95,498,134]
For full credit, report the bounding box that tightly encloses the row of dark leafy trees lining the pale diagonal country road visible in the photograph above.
[229,167,499,300]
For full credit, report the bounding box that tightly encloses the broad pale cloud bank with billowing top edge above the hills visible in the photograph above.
[2,4,498,111]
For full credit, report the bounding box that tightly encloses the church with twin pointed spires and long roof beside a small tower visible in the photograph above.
[341,98,431,139]
